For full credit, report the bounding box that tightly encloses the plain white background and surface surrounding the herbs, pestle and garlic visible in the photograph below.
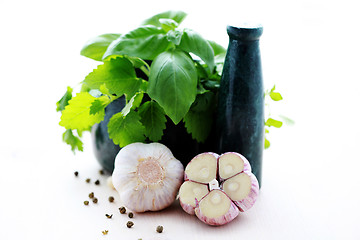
[0,0,360,240]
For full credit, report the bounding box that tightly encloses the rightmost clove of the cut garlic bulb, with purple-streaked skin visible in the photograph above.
[222,172,259,212]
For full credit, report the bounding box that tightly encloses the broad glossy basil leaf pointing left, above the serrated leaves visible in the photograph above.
[103,26,170,60]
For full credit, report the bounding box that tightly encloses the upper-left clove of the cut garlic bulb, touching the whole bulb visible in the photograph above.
[184,152,219,183]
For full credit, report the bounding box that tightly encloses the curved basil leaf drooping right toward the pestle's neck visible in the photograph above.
[179,29,215,71]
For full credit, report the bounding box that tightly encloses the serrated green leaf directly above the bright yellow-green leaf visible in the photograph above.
[84,57,141,97]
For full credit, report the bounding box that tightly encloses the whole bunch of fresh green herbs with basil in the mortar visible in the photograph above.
[57,11,226,151]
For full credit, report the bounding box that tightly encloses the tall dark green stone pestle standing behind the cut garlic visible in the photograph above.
[216,25,264,186]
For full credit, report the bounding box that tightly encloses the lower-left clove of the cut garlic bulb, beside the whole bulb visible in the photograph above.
[179,181,209,215]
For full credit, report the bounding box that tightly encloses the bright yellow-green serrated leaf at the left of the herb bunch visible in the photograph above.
[59,92,105,131]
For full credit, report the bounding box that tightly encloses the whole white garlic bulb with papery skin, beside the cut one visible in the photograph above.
[112,143,184,212]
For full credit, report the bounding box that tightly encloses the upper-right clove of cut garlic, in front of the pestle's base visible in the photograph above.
[218,152,251,180]
